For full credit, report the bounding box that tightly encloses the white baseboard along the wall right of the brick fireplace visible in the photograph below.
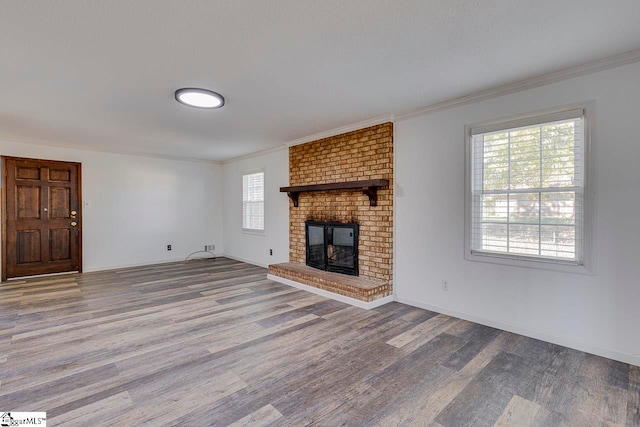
[395,295,640,366]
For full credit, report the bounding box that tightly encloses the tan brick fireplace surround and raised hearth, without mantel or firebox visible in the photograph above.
[269,123,393,302]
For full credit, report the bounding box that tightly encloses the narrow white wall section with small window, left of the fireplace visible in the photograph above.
[223,147,289,267]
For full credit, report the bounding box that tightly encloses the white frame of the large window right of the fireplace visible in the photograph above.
[465,101,595,274]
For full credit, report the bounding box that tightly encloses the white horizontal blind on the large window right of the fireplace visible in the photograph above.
[471,110,585,264]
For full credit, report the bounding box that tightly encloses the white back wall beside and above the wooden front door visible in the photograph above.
[0,141,224,271]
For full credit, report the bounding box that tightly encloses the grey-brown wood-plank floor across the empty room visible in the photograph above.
[0,258,640,427]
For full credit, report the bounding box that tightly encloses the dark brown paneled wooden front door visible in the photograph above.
[2,157,82,281]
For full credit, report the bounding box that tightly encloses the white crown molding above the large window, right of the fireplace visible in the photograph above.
[396,49,640,120]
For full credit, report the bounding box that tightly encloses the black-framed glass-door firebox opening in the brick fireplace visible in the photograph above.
[305,221,358,276]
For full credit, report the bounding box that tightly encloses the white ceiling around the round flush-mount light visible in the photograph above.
[0,0,640,160]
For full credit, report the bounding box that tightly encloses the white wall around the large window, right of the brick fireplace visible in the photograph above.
[394,63,640,365]
